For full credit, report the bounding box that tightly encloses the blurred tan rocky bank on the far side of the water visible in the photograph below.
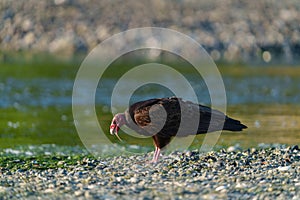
[0,0,300,63]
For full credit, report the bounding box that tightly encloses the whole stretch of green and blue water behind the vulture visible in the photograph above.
[0,57,300,148]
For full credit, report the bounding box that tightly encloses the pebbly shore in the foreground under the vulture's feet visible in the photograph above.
[0,146,300,199]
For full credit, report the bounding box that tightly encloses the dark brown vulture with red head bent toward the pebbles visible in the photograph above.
[110,97,247,162]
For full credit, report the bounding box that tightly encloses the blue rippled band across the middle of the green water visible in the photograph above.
[0,76,300,108]
